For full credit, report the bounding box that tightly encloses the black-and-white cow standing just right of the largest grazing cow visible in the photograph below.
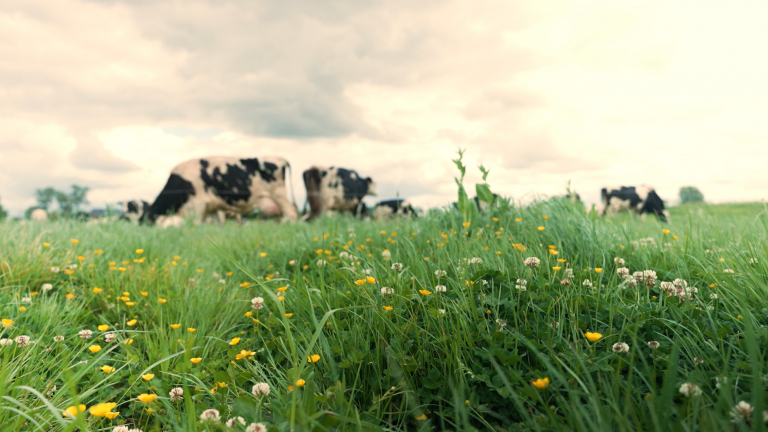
[303,166,378,220]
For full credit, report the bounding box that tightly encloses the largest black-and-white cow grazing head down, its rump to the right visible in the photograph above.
[146,156,297,223]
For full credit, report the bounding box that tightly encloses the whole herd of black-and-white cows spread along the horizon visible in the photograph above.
[27,156,669,227]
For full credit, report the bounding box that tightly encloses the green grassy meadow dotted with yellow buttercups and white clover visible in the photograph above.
[0,199,768,432]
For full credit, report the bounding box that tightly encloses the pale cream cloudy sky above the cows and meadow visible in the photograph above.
[0,0,768,215]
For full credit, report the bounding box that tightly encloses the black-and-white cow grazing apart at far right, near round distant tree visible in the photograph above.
[597,185,669,222]
